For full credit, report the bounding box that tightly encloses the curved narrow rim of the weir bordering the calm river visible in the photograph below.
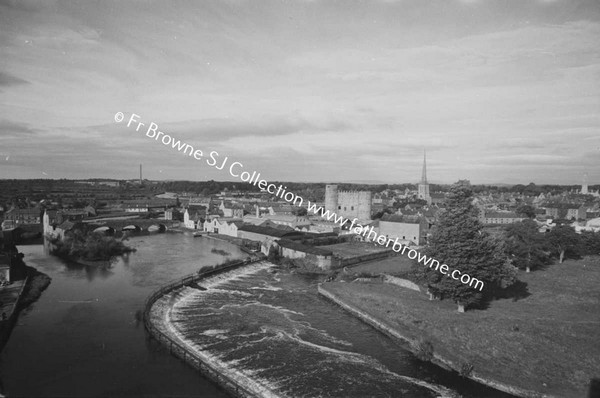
[143,258,263,398]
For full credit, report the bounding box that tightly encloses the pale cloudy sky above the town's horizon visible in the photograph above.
[0,0,600,185]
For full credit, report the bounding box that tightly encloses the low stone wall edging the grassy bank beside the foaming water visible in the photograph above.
[318,284,558,398]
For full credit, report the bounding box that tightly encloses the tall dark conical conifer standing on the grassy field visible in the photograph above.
[424,182,516,312]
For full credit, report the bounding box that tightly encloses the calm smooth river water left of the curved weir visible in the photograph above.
[0,234,245,397]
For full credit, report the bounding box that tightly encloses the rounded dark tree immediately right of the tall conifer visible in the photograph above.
[505,220,549,272]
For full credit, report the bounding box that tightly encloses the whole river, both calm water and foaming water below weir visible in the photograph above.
[0,234,508,398]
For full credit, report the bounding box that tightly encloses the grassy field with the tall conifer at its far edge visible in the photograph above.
[323,257,600,397]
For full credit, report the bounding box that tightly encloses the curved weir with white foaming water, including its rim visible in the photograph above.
[145,262,464,398]
